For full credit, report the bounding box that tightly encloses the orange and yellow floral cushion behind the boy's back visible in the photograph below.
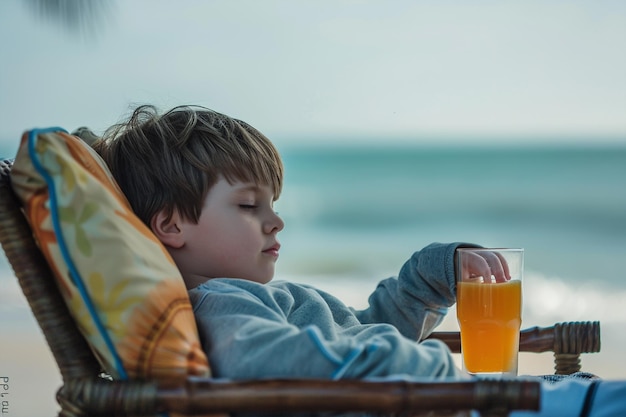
[11,128,209,382]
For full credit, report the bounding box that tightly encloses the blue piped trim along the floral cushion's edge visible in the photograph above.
[28,127,128,380]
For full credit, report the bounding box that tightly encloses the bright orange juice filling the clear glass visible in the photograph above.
[457,280,522,373]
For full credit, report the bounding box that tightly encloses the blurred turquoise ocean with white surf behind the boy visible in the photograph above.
[0,141,626,390]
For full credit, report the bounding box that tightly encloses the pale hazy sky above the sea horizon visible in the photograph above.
[0,0,626,151]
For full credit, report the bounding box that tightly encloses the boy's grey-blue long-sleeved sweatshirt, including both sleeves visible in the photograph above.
[189,243,473,379]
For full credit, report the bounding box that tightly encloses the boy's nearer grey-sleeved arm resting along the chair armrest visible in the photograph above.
[191,285,462,379]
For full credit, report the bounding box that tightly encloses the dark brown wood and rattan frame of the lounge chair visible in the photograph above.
[0,160,600,417]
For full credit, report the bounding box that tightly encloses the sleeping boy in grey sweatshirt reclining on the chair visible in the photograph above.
[95,106,506,378]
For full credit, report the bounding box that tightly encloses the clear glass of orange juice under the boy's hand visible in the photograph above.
[456,248,524,377]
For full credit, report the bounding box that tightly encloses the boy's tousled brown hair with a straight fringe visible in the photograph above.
[94,105,283,225]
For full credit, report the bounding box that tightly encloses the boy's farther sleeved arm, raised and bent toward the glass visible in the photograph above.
[355,243,479,340]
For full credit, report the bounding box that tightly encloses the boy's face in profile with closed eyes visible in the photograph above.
[172,177,285,287]
